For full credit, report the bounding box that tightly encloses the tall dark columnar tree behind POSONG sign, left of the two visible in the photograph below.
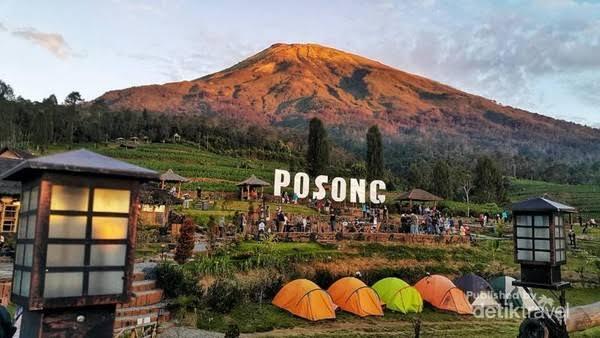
[306,117,329,177]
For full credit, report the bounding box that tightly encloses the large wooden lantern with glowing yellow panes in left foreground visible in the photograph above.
[4,150,158,337]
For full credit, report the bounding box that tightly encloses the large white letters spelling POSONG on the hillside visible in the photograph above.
[273,169,385,204]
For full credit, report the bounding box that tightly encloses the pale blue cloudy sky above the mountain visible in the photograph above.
[0,0,600,127]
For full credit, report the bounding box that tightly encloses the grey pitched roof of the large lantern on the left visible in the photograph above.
[0,149,158,180]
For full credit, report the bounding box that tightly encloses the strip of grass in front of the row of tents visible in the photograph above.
[196,304,519,337]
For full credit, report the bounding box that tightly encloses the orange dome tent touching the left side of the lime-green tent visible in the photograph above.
[327,277,383,317]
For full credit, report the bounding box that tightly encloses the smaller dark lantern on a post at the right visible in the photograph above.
[512,197,576,337]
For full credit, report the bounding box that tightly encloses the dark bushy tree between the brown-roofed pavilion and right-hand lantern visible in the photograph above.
[473,156,507,203]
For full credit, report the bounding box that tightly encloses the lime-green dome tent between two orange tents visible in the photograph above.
[373,277,423,313]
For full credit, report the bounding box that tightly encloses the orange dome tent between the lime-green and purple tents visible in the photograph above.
[415,275,473,315]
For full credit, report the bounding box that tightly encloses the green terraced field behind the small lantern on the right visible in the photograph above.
[509,180,600,219]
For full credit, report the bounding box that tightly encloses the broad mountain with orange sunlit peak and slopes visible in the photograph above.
[97,44,600,161]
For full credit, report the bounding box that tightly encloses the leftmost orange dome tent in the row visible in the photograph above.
[273,279,337,321]
